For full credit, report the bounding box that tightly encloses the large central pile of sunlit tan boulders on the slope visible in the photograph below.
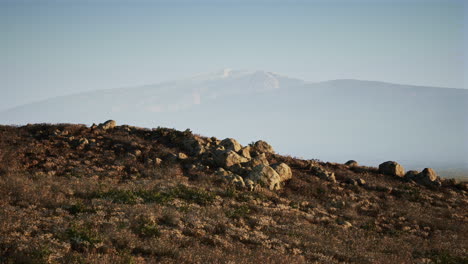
[182,136,292,190]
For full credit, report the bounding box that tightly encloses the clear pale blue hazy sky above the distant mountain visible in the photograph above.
[0,0,468,109]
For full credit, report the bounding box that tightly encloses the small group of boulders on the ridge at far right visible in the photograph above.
[379,161,441,186]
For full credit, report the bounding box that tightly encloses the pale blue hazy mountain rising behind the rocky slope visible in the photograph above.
[0,69,468,177]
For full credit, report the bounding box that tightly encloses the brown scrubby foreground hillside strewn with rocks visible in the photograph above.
[0,121,468,264]
